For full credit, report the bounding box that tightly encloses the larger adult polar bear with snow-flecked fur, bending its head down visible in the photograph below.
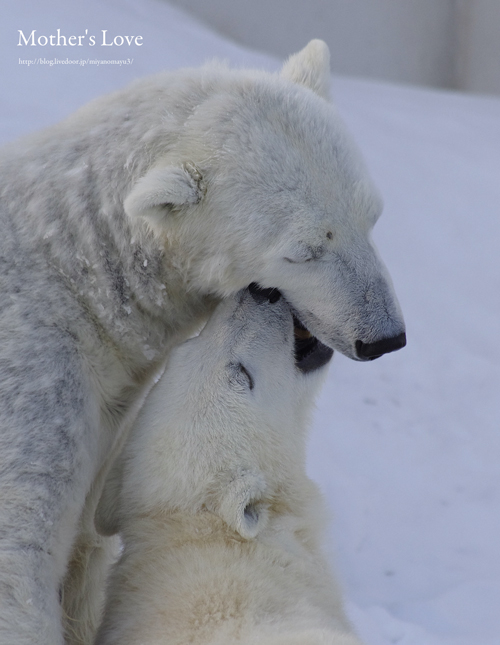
[0,41,405,645]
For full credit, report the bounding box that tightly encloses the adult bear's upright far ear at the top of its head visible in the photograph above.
[281,40,330,100]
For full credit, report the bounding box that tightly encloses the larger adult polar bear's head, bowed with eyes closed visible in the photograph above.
[124,40,406,361]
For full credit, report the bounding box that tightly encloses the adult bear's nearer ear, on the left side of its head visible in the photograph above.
[123,162,205,225]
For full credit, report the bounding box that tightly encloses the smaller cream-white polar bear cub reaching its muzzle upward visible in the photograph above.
[96,289,360,645]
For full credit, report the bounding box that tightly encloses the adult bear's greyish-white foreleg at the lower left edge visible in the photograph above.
[0,328,105,645]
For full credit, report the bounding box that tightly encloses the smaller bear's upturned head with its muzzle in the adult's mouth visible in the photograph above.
[96,284,333,538]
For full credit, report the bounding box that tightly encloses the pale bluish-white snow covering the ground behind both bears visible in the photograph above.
[0,0,500,645]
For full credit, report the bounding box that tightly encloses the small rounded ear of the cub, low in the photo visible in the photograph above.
[213,472,268,540]
